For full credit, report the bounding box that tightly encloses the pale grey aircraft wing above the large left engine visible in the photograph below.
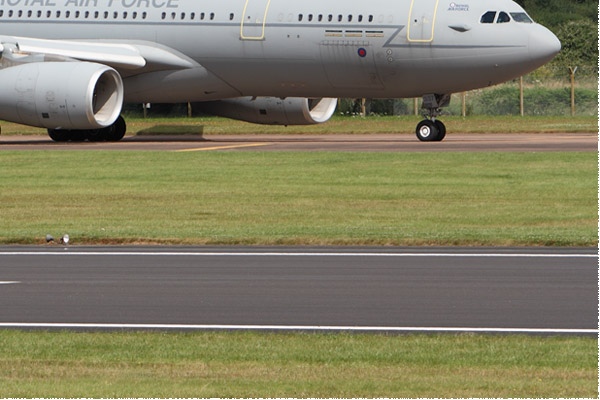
[0,36,198,76]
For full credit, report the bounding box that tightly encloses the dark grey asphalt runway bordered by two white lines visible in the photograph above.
[0,246,598,335]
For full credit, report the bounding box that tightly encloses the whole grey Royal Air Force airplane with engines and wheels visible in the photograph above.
[0,0,561,142]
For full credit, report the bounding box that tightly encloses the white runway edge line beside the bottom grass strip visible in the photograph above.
[0,322,599,335]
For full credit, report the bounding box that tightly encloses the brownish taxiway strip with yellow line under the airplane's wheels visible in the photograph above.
[0,133,598,152]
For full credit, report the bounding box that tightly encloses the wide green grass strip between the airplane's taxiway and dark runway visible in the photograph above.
[0,151,598,246]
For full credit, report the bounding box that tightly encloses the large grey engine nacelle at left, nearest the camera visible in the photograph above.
[0,62,124,129]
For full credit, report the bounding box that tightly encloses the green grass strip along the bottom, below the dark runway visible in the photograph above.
[0,331,598,398]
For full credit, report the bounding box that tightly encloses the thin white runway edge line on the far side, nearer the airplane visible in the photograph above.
[0,249,598,258]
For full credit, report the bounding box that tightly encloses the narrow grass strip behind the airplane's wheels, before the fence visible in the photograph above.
[0,116,598,136]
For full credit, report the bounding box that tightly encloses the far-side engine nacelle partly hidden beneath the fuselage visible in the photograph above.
[199,97,337,125]
